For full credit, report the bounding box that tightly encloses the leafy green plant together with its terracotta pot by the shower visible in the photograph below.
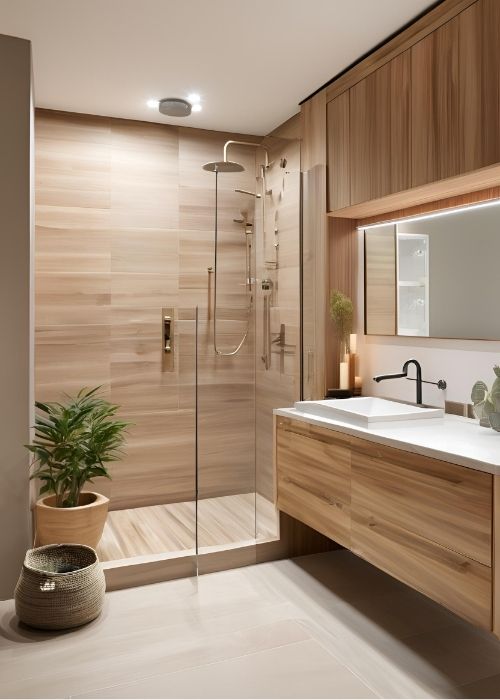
[26,387,128,548]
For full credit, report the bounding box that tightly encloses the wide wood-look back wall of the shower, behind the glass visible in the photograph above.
[36,110,260,509]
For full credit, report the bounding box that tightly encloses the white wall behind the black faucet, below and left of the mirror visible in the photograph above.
[358,228,500,406]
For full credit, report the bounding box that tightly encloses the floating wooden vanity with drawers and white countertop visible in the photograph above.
[274,399,500,636]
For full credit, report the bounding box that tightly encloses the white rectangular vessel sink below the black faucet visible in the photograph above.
[295,396,443,426]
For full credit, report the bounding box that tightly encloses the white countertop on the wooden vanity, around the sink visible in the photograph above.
[274,408,500,474]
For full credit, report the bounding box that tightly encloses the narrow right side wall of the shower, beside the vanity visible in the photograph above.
[256,114,300,508]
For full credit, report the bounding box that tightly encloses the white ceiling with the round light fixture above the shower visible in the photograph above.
[0,0,431,134]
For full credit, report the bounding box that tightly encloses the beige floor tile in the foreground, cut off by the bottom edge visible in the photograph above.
[75,639,376,698]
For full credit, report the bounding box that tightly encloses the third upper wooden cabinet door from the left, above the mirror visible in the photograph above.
[411,17,460,187]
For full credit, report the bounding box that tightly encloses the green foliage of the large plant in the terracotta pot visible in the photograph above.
[26,387,129,508]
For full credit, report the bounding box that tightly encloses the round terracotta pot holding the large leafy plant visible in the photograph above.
[35,491,109,549]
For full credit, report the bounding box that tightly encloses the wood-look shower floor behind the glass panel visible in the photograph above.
[98,493,277,561]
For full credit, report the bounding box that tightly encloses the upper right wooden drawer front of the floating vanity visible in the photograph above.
[351,442,493,566]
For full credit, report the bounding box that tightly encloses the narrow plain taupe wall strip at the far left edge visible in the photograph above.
[0,35,33,599]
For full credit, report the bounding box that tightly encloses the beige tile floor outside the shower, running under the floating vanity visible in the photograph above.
[0,550,500,698]
